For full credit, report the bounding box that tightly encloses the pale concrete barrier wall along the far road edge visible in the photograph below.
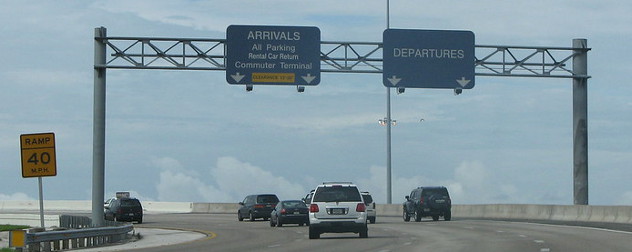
[0,200,632,224]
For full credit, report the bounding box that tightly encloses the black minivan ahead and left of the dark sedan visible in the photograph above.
[237,194,279,221]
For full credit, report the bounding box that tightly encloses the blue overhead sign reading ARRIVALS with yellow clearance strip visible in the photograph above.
[226,25,320,86]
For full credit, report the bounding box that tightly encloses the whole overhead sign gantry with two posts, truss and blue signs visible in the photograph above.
[92,26,590,226]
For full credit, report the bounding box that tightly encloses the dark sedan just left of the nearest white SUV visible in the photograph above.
[270,200,309,227]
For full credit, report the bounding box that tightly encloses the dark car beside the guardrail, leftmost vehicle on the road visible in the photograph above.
[104,198,143,224]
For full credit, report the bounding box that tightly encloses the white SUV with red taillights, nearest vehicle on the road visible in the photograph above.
[309,182,369,239]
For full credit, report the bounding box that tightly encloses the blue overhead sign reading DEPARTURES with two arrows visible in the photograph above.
[382,29,475,89]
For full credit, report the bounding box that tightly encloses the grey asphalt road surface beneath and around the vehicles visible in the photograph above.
[134,214,632,252]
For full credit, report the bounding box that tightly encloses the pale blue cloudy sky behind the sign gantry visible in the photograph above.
[0,0,632,205]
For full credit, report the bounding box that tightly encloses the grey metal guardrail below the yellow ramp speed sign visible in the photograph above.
[26,215,134,251]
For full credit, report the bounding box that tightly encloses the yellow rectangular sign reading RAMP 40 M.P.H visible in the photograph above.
[20,133,57,178]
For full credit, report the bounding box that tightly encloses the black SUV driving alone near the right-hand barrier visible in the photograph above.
[403,186,452,221]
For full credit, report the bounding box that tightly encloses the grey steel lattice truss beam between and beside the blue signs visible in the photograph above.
[95,37,590,78]
